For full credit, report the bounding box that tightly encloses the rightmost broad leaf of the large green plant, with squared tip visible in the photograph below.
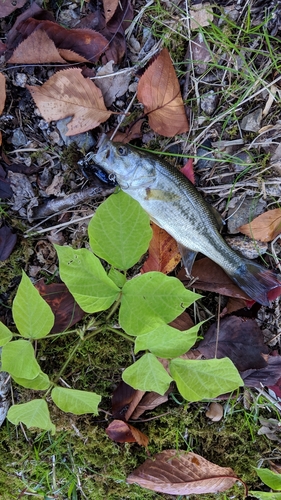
[169,358,244,401]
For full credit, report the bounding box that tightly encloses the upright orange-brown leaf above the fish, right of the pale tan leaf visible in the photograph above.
[137,49,188,137]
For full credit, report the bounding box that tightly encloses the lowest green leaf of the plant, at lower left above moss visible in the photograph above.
[7,399,56,434]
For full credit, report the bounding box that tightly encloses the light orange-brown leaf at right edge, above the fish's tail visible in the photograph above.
[238,208,281,242]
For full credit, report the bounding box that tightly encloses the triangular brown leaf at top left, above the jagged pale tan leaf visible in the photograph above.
[8,29,65,64]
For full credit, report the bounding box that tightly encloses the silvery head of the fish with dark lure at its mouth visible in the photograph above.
[94,137,156,190]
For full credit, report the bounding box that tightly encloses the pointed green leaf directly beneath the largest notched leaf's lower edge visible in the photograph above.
[135,323,202,358]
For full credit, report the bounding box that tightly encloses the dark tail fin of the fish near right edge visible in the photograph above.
[231,260,281,306]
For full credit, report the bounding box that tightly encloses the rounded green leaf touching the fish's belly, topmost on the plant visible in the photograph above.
[88,191,152,270]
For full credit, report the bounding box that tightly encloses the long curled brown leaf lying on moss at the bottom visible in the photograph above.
[127,450,238,495]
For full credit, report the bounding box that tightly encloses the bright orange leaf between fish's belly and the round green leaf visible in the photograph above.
[141,222,181,274]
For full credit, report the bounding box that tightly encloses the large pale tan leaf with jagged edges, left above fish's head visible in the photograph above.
[27,68,112,136]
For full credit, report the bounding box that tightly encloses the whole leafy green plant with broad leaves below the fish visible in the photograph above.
[0,191,243,432]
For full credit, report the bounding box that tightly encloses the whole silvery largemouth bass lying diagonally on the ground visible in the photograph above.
[93,138,281,305]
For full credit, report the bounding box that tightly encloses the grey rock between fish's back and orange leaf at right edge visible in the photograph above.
[227,198,266,234]
